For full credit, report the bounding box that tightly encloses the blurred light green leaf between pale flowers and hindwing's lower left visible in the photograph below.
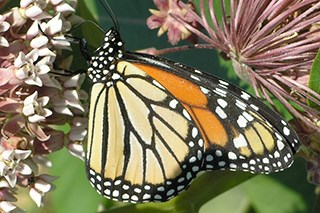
[49,149,106,213]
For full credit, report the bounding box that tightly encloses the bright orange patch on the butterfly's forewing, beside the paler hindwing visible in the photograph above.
[133,63,228,148]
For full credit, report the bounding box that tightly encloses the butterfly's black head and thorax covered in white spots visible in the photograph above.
[88,28,124,83]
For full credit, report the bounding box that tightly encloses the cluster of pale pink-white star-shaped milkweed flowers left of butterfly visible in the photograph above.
[0,0,87,212]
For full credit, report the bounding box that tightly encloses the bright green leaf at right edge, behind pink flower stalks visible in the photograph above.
[307,48,320,110]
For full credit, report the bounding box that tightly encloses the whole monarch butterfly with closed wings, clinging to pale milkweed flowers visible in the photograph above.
[83,25,299,203]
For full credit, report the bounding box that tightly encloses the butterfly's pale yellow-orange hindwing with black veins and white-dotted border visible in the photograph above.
[86,61,204,202]
